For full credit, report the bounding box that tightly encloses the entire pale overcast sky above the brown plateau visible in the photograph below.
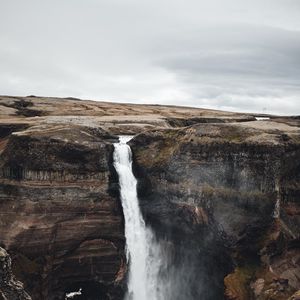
[0,0,300,114]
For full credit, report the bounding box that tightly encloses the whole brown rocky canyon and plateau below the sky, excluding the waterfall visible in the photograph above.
[0,96,300,300]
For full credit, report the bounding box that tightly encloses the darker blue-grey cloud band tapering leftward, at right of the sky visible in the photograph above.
[159,26,300,80]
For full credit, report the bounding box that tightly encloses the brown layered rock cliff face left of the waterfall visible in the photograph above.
[0,125,125,299]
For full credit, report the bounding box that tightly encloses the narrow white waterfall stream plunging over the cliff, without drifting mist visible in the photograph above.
[114,136,166,300]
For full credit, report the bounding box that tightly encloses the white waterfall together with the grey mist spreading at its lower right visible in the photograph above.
[114,136,200,300]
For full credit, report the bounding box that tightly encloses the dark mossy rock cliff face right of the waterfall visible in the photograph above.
[131,122,300,299]
